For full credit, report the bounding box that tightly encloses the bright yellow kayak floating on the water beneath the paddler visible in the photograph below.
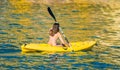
[21,41,96,52]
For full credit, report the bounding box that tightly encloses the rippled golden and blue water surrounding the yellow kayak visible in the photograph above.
[0,0,120,70]
